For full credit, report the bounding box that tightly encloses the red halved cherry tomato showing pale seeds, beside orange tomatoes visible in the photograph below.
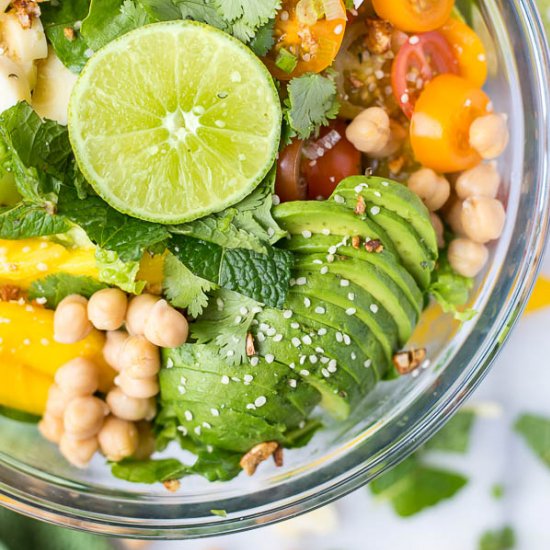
[392,31,459,118]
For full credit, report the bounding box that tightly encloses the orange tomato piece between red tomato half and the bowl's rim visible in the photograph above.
[439,18,487,88]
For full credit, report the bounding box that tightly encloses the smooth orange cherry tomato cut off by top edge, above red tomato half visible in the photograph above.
[372,0,454,32]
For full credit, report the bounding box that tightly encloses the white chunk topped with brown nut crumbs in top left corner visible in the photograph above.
[0,12,48,63]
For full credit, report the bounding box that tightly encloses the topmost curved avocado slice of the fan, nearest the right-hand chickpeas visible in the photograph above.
[332,176,438,260]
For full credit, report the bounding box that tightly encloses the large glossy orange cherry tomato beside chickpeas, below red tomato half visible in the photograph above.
[410,74,490,172]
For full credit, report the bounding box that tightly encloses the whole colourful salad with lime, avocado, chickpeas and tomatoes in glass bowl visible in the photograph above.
[0,0,508,490]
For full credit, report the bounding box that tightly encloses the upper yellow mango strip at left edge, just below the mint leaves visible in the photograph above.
[0,239,98,289]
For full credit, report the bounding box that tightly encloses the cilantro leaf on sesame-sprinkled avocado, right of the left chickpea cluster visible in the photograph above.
[190,289,262,365]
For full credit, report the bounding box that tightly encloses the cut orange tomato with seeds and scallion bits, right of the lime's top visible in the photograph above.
[264,0,346,80]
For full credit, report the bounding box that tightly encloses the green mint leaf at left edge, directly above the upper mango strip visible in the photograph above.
[0,202,71,240]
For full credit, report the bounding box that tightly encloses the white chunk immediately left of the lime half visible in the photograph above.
[32,49,77,124]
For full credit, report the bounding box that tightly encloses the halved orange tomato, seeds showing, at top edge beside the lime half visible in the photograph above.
[264,0,346,80]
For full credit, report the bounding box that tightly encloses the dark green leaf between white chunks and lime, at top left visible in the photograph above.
[40,0,90,73]
